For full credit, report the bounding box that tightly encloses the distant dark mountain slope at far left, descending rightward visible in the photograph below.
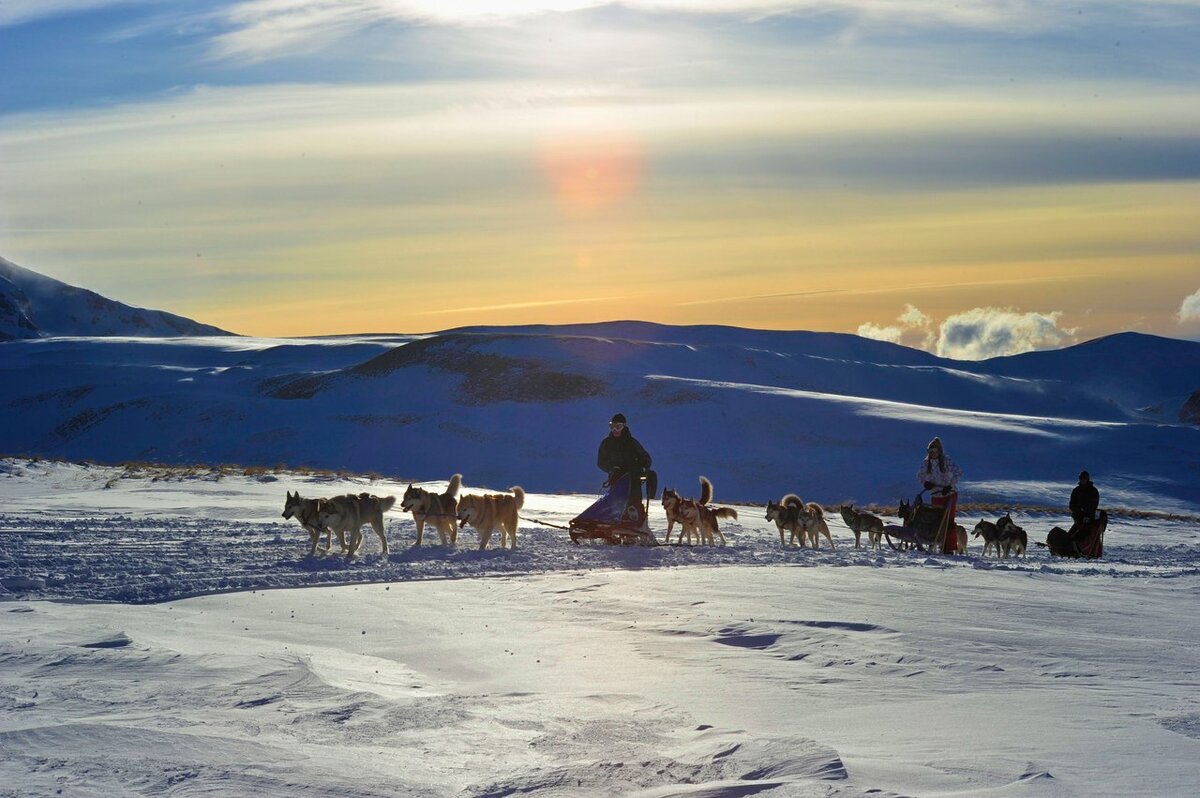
[0,258,233,341]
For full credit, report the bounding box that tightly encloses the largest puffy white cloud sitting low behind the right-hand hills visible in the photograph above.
[936,307,1075,360]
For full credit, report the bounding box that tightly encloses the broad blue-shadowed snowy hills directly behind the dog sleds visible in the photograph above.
[0,322,1200,509]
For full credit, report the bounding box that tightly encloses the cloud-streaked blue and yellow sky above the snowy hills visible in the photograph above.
[0,0,1200,359]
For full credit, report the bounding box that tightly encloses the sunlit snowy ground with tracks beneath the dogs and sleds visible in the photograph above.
[0,461,1200,797]
